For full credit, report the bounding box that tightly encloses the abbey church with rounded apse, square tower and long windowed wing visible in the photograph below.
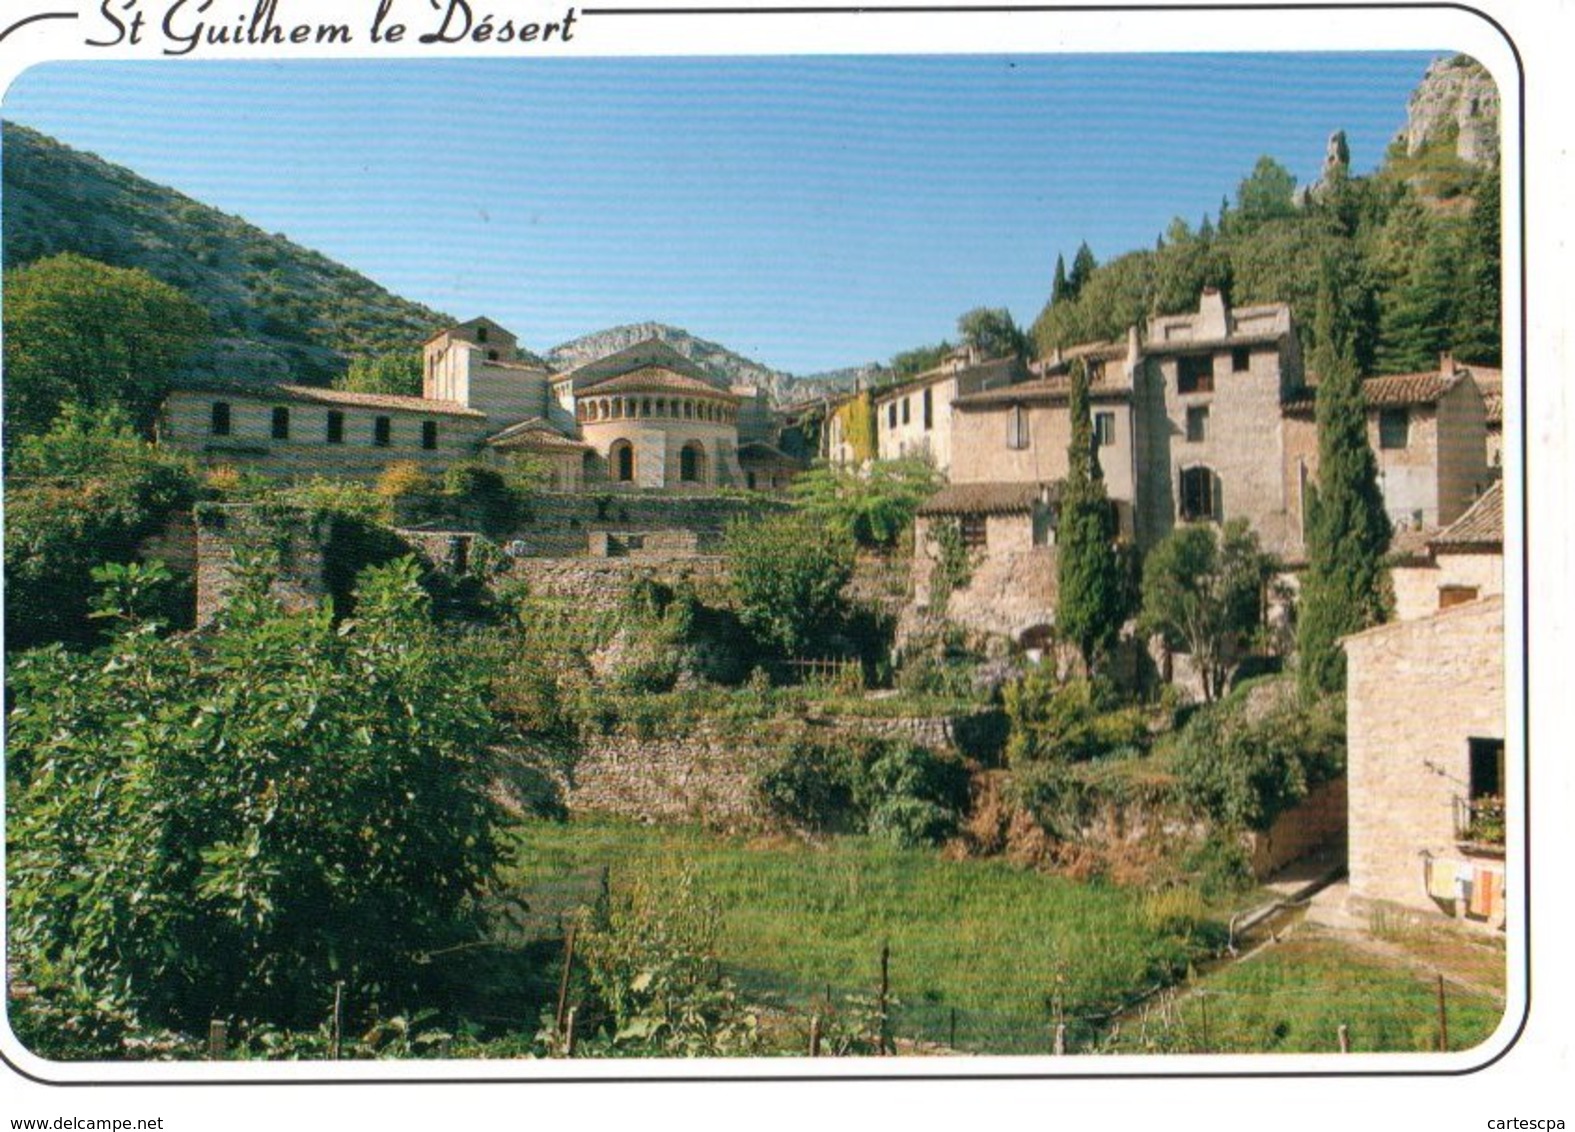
[159,318,802,491]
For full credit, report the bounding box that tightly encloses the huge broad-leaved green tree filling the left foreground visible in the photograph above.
[6,559,495,1027]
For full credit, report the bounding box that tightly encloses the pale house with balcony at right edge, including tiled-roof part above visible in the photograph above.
[1343,485,1507,927]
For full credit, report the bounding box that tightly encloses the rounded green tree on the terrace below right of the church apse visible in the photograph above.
[725,512,854,657]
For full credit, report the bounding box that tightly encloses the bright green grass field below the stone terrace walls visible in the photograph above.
[512,819,1217,1053]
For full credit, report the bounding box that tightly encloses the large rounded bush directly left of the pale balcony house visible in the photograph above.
[1175,683,1345,831]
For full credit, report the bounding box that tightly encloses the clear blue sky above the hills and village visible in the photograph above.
[3,52,1433,373]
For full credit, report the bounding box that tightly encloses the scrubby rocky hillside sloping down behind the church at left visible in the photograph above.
[3,123,454,384]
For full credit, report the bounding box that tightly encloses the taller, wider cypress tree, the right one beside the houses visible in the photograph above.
[1296,260,1394,696]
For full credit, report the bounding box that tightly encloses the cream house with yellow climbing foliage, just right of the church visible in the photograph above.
[873,348,1027,475]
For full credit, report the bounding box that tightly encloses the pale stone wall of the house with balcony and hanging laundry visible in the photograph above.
[1345,597,1514,915]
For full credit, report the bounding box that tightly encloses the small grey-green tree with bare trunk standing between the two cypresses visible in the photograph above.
[1142,518,1277,701]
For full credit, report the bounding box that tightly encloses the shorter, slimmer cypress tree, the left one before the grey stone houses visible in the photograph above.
[1055,359,1132,671]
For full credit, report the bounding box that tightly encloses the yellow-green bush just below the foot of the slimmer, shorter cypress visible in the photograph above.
[1005,666,1148,765]
